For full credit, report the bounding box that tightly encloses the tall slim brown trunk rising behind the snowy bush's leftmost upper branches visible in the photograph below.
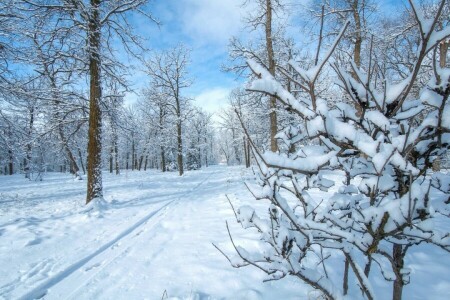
[265,0,278,152]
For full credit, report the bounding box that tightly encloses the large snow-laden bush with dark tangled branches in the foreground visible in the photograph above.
[222,1,450,299]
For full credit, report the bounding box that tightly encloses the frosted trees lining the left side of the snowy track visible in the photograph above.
[0,1,218,186]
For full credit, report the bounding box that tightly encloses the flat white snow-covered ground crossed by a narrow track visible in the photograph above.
[0,166,450,299]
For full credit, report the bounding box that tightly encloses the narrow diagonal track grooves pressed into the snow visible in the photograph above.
[18,170,219,300]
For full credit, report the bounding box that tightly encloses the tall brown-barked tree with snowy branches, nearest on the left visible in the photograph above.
[17,0,156,203]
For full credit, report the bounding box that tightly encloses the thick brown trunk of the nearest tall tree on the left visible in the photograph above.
[86,0,103,204]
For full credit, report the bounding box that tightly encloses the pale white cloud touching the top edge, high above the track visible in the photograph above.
[181,0,242,45]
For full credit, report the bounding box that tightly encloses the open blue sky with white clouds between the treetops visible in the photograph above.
[127,0,407,117]
